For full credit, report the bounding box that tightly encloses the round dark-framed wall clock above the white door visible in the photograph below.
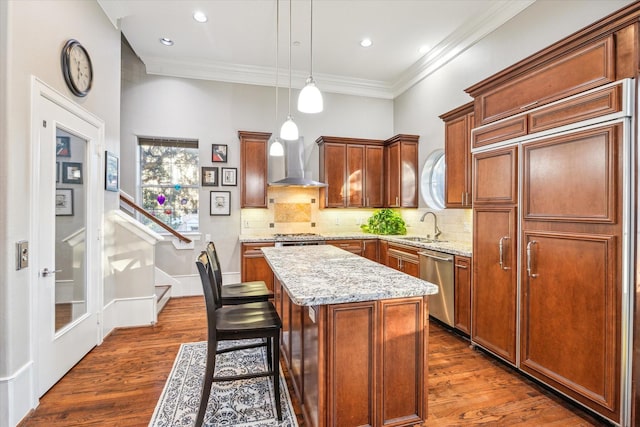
[61,39,93,96]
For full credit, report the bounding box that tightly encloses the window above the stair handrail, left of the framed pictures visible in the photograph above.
[138,138,199,233]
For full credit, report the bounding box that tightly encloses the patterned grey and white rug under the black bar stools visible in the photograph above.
[149,341,298,427]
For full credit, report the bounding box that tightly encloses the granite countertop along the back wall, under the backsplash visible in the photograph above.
[239,231,472,257]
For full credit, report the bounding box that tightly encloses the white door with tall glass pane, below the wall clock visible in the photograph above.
[31,83,103,396]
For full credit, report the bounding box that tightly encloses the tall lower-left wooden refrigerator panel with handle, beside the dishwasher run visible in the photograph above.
[471,208,517,364]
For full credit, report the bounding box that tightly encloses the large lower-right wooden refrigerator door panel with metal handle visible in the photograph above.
[520,231,620,418]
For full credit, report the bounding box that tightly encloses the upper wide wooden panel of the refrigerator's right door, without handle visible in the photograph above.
[523,125,621,223]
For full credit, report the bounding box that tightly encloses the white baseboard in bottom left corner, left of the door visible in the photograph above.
[0,361,38,426]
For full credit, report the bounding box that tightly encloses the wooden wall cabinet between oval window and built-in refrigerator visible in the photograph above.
[440,102,474,208]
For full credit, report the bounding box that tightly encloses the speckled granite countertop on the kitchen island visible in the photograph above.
[261,245,438,306]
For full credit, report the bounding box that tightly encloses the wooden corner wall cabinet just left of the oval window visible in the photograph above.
[385,134,419,208]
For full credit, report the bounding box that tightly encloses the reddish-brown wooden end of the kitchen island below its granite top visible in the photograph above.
[290,292,428,427]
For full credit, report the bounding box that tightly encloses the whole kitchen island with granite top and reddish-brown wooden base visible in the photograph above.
[262,245,437,427]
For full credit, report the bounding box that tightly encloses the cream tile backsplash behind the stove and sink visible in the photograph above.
[240,187,472,243]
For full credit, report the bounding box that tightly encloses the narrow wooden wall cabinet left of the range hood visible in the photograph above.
[238,131,271,208]
